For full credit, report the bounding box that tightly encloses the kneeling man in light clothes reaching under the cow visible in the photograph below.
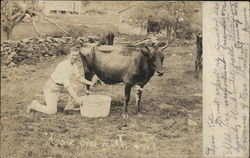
[27,47,94,114]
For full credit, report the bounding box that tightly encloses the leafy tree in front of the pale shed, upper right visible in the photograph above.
[129,1,201,39]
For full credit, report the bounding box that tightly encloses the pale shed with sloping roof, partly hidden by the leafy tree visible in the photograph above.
[118,5,148,35]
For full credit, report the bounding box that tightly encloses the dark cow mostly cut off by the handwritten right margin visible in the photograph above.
[194,33,203,78]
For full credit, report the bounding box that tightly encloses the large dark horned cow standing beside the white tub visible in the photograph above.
[80,44,168,118]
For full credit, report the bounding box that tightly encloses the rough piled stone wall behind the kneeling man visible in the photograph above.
[1,37,98,66]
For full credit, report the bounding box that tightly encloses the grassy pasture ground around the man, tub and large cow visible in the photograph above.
[1,47,202,158]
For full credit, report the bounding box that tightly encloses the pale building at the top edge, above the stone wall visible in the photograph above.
[39,1,81,14]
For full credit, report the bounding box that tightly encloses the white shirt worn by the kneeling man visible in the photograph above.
[50,59,80,87]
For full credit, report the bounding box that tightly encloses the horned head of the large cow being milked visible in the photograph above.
[141,44,168,76]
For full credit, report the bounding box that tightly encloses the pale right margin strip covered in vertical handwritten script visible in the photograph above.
[203,1,250,158]
